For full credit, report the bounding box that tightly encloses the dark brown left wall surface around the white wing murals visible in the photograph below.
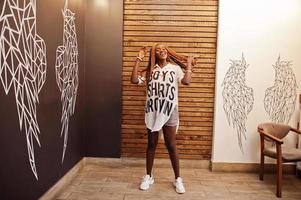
[0,0,85,200]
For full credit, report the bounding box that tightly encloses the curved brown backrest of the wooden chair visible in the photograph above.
[258,123,291,139]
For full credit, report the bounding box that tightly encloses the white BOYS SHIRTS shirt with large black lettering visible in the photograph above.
[139,63,184,132]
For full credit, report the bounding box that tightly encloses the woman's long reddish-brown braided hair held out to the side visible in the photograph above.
[145,43,196,82]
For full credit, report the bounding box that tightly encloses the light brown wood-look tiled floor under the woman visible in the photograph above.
[57,159,301,200]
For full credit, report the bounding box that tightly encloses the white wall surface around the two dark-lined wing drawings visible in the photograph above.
[212,0,301,163]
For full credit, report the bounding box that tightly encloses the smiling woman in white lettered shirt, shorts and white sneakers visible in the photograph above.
[131,44,195,194]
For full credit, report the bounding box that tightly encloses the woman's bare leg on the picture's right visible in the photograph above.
[163,126,180,179]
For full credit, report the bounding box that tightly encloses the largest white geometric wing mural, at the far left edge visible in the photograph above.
[0,0,46,179]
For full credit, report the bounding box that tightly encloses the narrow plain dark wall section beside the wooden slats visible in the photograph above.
[85,0,123,157]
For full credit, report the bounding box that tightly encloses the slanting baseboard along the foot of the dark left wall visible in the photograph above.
[39,158,85,200]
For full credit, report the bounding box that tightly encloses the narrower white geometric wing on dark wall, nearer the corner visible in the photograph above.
[55,0,78,162]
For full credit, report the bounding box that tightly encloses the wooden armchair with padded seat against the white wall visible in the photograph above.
[257,123,301,197]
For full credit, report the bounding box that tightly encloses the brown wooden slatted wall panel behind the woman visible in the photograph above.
[122,0,218,160]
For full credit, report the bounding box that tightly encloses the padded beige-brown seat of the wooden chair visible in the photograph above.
[263,146,301,162]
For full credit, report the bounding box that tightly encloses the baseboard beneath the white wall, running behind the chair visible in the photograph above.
[210,162,296,174]
